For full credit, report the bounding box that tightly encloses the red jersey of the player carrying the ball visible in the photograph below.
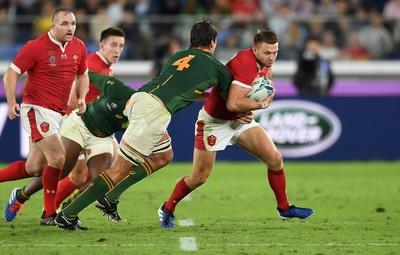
[204,49,259,120]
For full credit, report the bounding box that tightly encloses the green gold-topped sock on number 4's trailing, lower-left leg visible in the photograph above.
[62,172,115,218]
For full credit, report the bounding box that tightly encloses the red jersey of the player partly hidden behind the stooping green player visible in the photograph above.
[85,52,112,103]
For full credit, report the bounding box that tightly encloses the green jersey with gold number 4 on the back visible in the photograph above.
[138,48,232,114]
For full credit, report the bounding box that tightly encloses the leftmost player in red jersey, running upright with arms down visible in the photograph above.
[0,8,89,224]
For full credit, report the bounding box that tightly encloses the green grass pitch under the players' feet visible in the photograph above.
[0,162,400,255]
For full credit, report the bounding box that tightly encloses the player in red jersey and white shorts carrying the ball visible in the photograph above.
[158,30,314,228]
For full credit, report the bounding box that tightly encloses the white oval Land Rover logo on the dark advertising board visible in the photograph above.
[255,100,342,158]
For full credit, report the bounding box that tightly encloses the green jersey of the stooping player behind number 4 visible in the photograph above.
[82,71,136,137]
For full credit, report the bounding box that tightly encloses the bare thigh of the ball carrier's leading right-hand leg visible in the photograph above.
[236,125,282,168]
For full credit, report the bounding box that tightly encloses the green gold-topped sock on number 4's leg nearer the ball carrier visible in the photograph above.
[107,160,153,202]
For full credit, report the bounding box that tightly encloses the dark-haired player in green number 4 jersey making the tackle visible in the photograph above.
[55,20,239,230]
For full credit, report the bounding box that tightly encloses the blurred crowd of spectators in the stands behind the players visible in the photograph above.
[0,0,400,61]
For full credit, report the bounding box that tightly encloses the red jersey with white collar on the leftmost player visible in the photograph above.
[10,33,88,114]
